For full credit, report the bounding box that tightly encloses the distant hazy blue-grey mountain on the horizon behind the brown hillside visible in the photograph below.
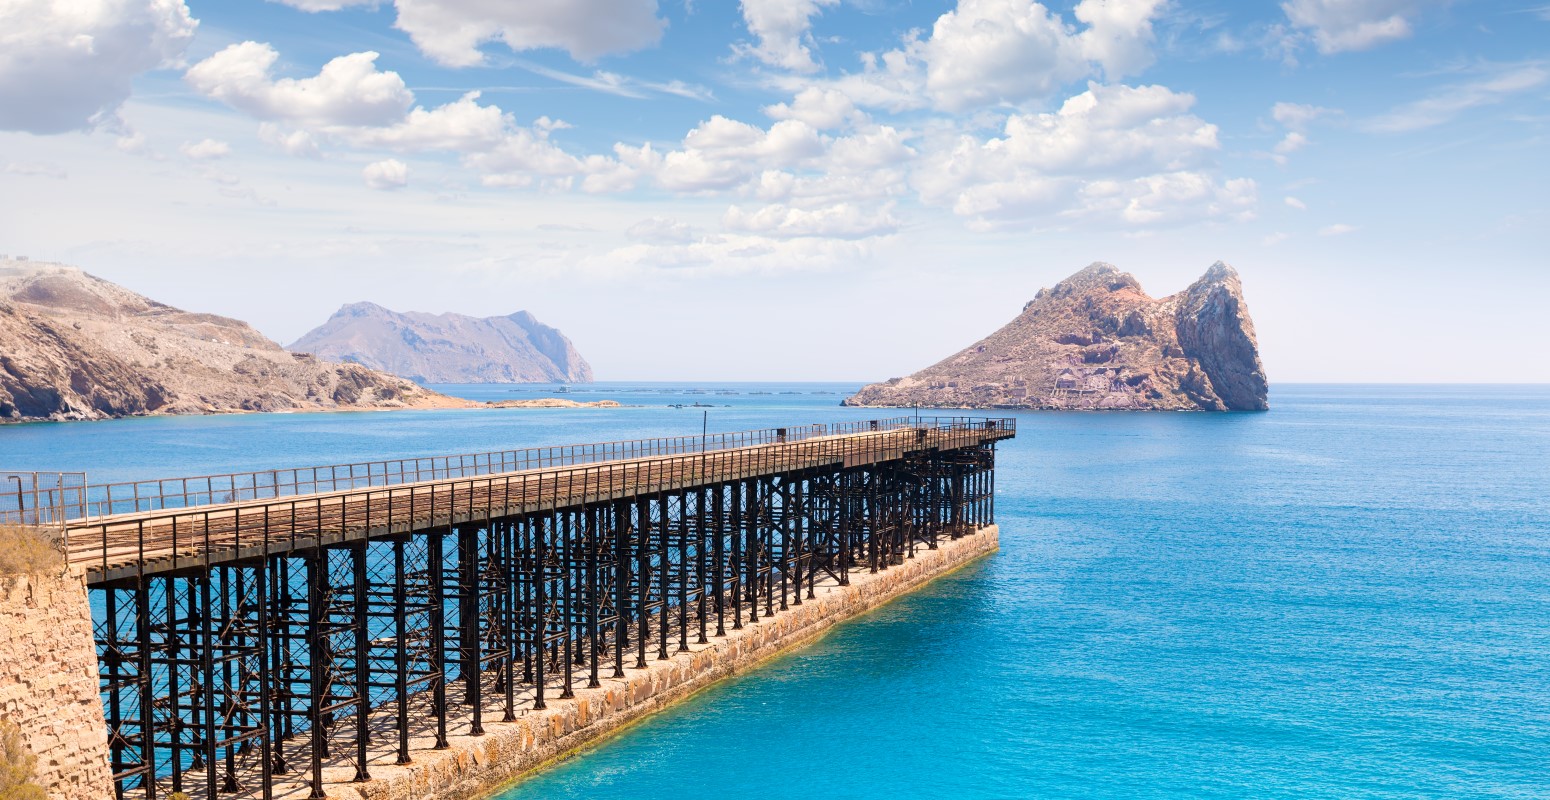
[290,302,592,383]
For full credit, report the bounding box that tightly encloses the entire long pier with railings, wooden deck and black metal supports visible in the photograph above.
[0,417,1015,800]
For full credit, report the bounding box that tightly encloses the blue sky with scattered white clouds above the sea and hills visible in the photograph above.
[0,0,1550,381]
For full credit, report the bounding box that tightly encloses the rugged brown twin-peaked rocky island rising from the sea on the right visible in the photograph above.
[843,262,1269,411]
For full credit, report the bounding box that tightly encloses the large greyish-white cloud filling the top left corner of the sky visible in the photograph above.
[0,0,198,133]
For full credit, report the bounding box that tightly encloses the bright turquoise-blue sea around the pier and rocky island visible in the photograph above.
[0,383,1550,800]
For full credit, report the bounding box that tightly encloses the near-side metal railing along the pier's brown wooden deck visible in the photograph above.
[57,417,1017,574]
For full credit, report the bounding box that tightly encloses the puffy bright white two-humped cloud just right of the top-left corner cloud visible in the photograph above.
[183,42,414,126]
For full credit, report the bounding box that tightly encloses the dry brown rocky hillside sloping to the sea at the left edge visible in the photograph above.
[0,259,461,422]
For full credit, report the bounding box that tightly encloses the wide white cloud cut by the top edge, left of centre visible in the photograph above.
[395,0,667,67]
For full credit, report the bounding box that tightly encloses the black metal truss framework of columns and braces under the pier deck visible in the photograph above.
[91,439,995,800]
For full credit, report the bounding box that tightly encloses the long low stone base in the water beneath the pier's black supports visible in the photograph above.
[341,526,998,800]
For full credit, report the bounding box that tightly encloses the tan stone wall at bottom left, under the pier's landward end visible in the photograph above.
[0,575,112,800]
